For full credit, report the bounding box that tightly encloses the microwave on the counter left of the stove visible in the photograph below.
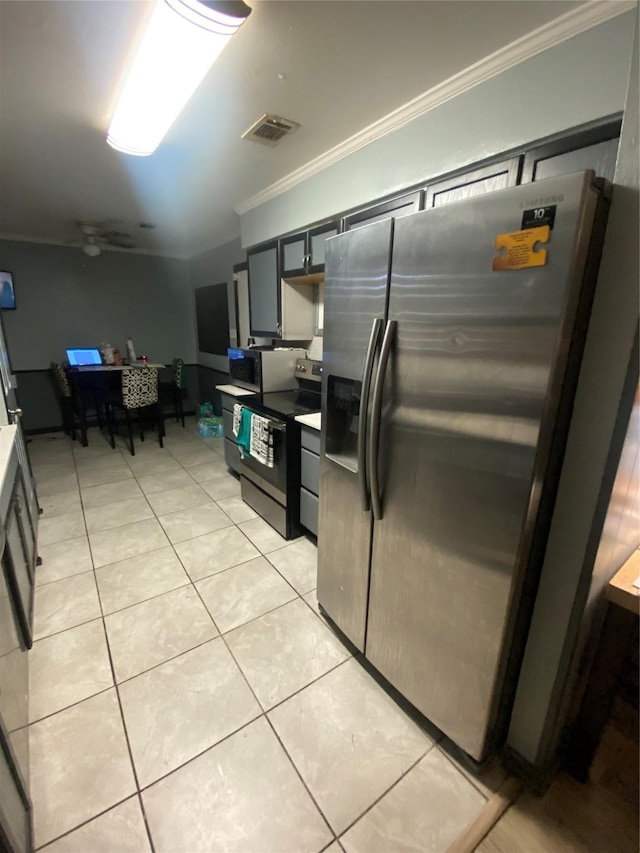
[227,347,306,394]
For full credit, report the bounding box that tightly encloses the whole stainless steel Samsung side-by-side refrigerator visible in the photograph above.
[318,172,607,760]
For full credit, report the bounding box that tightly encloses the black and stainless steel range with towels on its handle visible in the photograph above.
[240,358,322,539]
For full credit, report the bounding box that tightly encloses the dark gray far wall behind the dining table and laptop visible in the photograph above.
[0,240,196,430]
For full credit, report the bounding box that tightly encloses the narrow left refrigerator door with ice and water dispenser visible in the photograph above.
[318,219,393,651]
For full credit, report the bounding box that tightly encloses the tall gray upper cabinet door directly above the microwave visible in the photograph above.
[247,242,281,338]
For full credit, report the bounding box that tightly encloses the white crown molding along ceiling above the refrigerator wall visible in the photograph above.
[234,0,638,216]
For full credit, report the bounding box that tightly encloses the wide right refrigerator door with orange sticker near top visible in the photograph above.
[366,174,596,759]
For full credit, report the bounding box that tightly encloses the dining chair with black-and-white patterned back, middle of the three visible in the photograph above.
[107,367,164,456]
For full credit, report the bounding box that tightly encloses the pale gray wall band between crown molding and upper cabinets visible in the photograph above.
[241,12,635,247]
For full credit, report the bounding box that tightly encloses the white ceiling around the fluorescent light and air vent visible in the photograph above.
[0,0,596,256]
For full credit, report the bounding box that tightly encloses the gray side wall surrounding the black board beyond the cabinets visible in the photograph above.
[189,237,246,412]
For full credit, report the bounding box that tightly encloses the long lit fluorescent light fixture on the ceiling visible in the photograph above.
[107,0,251,157]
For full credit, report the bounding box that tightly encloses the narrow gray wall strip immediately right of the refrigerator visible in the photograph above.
[508,15,640,766]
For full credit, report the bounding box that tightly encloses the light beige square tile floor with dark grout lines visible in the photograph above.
[28,419,504,853]
